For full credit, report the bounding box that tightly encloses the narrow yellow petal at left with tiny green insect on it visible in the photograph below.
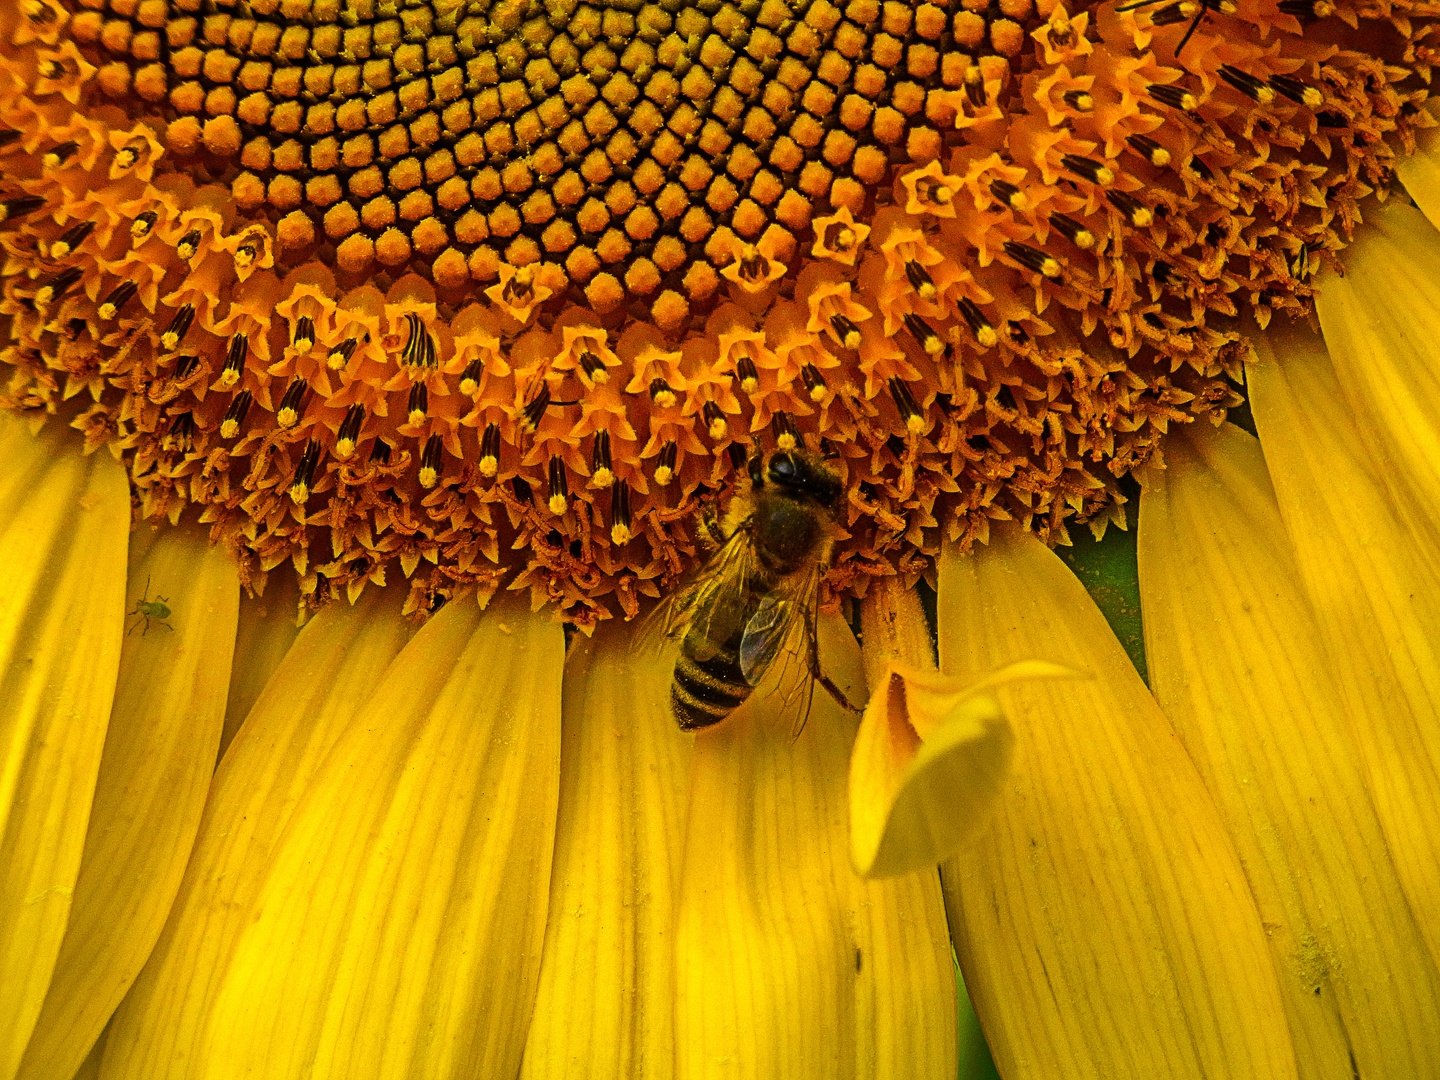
[19,528,239,1080]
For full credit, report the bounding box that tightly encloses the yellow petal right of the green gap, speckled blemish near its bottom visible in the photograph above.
[1139,425,1440,1080]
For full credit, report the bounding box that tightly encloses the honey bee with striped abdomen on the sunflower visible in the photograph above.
[658,449,855,730]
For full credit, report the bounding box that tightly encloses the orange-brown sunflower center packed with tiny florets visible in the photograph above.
[0,0,1434,625]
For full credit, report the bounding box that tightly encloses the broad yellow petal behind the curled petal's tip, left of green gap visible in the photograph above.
[939,527,1296,1080]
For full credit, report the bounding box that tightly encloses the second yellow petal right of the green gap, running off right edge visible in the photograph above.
[1246,331,1440,960]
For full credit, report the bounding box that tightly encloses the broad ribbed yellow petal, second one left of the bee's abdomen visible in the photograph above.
[199,600,564,1080]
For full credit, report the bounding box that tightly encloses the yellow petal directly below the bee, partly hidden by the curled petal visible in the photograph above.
[675,619,956,1080]
